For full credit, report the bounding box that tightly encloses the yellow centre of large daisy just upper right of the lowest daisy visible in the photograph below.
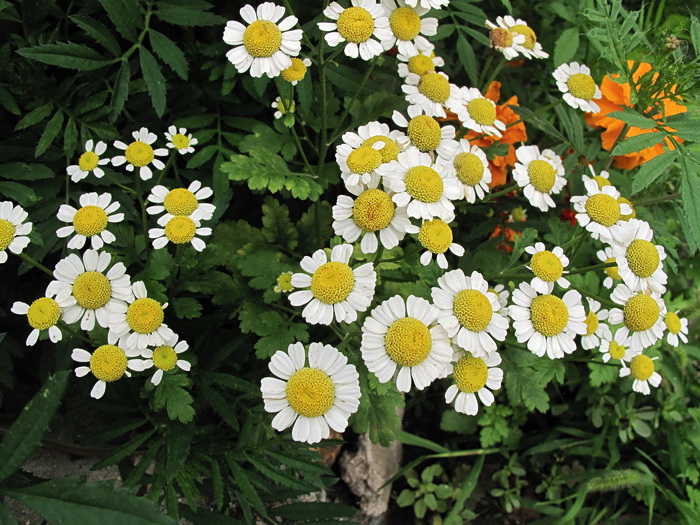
[384,317,433,366]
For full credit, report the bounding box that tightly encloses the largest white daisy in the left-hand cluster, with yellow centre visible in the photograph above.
[46,250,133,331]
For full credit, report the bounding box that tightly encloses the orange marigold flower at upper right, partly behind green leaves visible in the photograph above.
[586,61,688,170]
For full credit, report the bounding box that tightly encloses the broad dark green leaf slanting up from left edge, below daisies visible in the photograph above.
[0,370,70,481]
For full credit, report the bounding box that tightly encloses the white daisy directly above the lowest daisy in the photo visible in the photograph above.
[289,244,377,324]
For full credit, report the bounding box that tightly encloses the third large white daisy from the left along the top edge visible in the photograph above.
[382,0,438,55]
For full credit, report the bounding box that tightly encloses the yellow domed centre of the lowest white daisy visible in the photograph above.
[286,368,335,417]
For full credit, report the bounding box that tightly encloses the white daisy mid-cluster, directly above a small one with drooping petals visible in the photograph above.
[380,148,461,222]
